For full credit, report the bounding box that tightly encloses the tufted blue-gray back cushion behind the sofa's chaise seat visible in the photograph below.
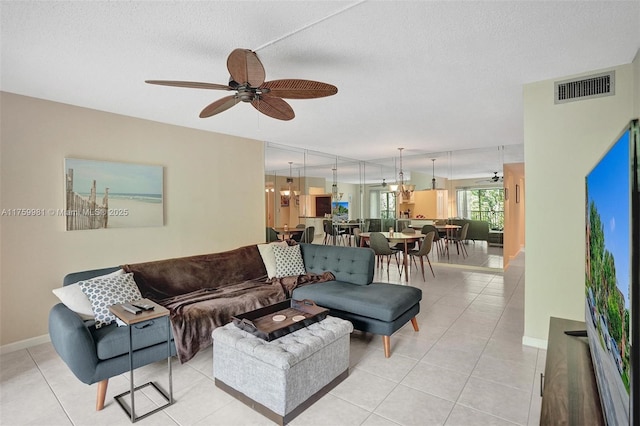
[300,244,375,285]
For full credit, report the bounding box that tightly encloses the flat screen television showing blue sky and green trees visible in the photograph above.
[585,120,640,425]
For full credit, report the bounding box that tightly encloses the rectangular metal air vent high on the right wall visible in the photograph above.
[555,71,616,104]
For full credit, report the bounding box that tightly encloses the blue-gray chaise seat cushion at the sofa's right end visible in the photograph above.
[292,281,422,321]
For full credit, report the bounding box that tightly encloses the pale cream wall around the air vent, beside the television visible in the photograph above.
[523,59,638,346]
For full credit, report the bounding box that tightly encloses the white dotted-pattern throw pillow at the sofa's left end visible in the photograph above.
[78,273,142,328]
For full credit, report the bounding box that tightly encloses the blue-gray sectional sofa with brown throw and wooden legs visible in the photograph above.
[49,244,422,409]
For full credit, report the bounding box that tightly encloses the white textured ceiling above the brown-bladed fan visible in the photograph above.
[0,0,640,181]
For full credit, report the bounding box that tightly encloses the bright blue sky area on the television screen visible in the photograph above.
[587,131,631,308]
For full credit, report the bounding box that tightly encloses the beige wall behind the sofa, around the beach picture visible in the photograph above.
[0,93,265,349]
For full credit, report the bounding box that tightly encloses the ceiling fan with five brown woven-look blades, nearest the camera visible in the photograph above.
[145,49,338,120]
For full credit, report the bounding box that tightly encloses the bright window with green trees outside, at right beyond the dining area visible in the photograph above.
[456,188,504,230]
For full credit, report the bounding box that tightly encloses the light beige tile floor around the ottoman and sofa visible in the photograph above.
[0,248,546,426]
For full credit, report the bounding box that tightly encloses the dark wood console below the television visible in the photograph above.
[540,317,605,426]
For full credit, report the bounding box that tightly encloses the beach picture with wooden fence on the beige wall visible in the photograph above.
[64,158,164,231]
